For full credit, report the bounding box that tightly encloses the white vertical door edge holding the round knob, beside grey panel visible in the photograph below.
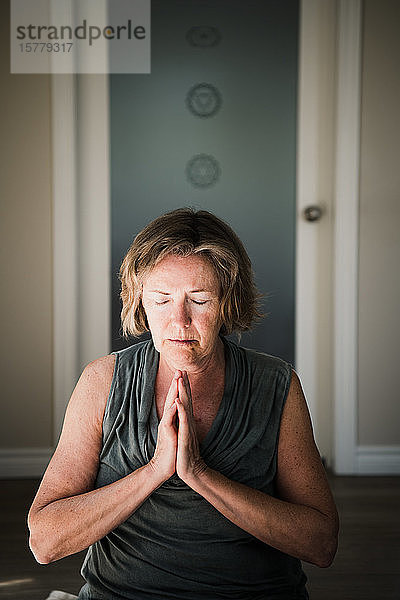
[295,0,337,465]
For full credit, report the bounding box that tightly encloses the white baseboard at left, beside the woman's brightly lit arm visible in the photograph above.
[0,448,54,479]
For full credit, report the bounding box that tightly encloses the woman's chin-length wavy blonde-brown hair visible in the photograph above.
[119,207,263,338]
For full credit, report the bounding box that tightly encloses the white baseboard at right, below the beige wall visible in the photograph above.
[356,446,400,475]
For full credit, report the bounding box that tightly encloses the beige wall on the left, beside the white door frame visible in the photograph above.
[0,1,53,464]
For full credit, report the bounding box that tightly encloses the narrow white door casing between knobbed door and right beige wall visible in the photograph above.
[334,0,362,474]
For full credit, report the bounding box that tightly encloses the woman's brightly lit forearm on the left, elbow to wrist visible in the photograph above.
[28,464,162,563]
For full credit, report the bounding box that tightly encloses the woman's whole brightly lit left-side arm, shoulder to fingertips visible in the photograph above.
[28,355,176,564]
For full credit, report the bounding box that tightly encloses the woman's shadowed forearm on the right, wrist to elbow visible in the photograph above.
[187,468,337,567]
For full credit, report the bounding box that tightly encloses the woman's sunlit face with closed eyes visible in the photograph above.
[142,254,221,371]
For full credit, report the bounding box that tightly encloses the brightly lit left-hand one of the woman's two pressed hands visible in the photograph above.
[150,371,181,482]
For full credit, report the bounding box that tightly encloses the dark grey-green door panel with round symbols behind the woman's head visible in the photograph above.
[110,0,298,362]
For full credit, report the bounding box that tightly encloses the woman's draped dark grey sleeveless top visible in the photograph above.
[79,338,308,600]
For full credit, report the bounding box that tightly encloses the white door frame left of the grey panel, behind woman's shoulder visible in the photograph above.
[52,75,111,444]
